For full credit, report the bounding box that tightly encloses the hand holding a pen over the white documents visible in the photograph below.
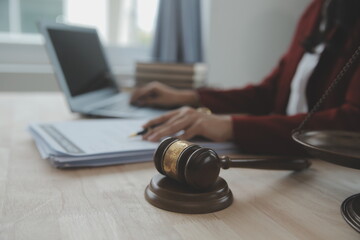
[143,107,233,142]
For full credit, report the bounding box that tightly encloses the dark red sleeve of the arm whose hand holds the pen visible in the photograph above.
[232,65,360,154]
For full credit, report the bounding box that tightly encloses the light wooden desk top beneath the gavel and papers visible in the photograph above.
[0,93,360,240]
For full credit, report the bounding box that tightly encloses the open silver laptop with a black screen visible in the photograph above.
[38,22,165,118]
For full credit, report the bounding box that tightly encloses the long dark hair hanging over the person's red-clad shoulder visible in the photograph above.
[302,0,360,52]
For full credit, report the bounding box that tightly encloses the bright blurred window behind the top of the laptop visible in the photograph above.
[0,0,158,47]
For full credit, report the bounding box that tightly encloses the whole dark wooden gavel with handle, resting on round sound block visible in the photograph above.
[145,138,310,213]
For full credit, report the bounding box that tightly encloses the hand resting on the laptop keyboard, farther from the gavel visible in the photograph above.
[130,82,199,108]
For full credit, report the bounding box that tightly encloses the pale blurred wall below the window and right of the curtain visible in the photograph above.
[0,0,310,91]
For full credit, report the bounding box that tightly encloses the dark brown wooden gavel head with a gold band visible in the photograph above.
[154,138,220,190]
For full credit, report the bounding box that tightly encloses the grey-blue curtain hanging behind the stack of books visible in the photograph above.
[152,0,203,63]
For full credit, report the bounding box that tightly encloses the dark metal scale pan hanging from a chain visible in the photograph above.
[292,131,360,169]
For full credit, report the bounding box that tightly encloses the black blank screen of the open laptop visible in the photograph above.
[48,29,115,97]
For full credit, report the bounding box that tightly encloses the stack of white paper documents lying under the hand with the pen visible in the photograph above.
[29,119,237,168]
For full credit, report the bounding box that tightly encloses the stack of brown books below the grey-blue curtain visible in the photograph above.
[135,62,207,89]
